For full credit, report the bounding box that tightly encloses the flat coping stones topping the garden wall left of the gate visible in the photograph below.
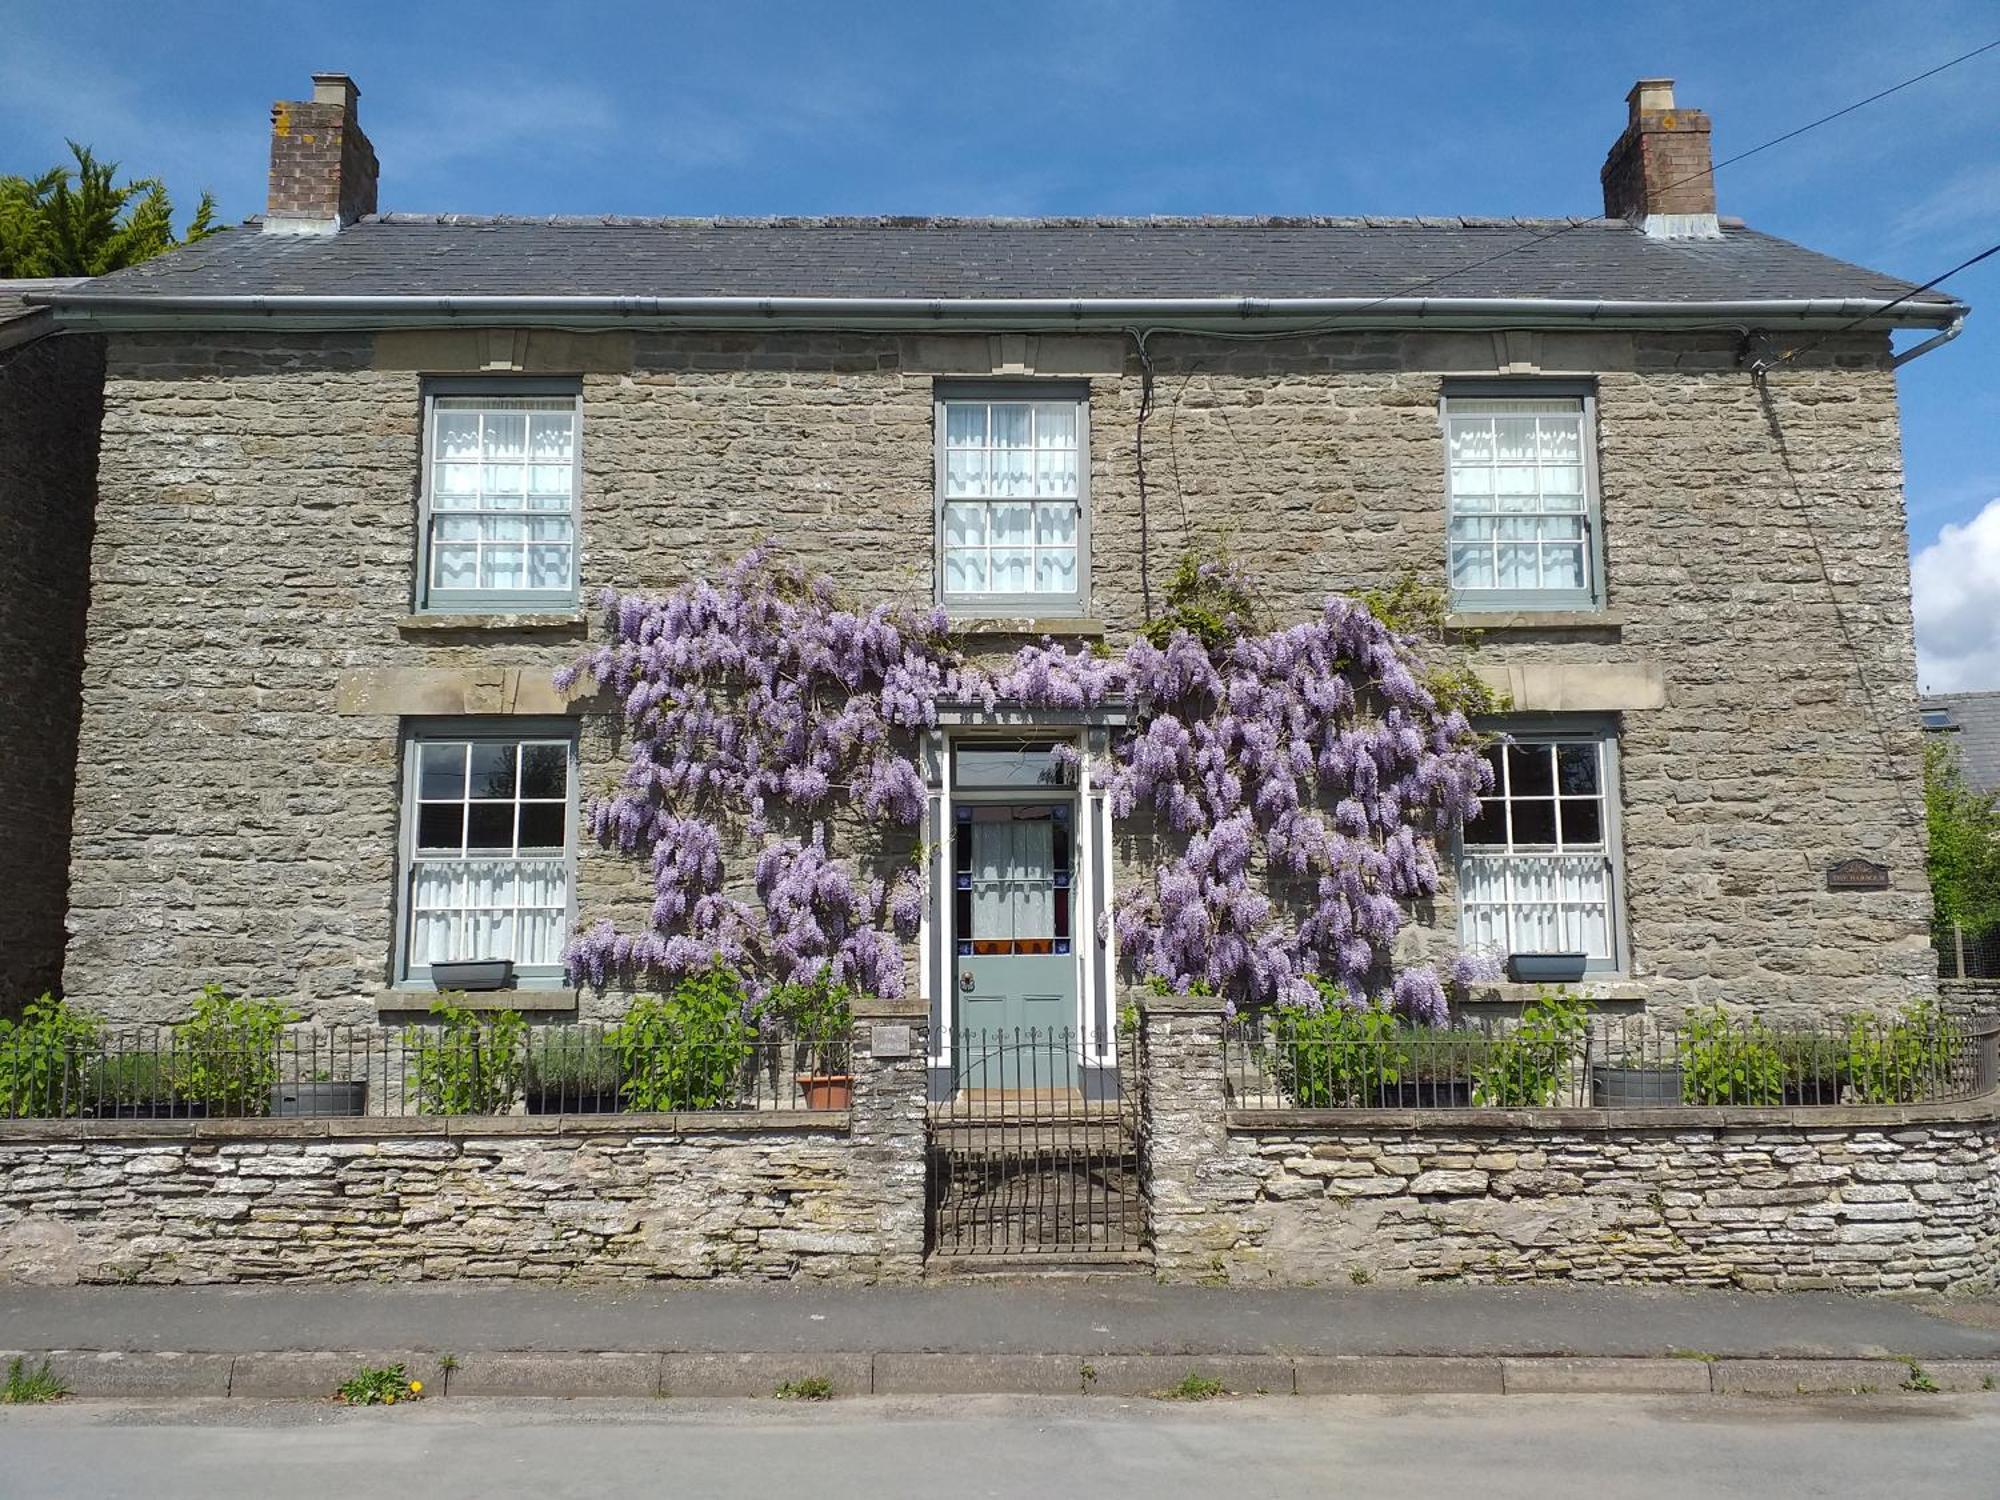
[0,1110,852,1142]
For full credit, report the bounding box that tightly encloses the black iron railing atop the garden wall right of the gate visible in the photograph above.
[1224,1006,1996,1110]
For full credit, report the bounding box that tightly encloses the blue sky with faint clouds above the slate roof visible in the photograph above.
[11,0,2000,688]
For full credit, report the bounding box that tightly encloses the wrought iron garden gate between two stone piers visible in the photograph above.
[926,1030,1146,1260]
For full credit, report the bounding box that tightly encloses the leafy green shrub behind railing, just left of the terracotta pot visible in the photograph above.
[604,964,756,1114]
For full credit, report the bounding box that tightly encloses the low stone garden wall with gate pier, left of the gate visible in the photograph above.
[0,1026,924,1284]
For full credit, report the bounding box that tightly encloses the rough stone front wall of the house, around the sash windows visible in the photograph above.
[70,330,1934,1020]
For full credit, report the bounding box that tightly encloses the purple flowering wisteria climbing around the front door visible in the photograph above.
[562,548,1490,1022]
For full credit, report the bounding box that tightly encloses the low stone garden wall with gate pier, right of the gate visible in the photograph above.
[1144,1002,2000,1292]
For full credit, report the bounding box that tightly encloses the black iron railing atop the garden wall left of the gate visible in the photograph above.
[0,1018,854,1120]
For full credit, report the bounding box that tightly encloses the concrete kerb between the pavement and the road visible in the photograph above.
[11,1350,2000,1400]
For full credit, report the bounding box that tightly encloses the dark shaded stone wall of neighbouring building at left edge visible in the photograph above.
[0,324,104,1016]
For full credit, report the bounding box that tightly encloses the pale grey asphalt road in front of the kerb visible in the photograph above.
[0,1396,2000,1500]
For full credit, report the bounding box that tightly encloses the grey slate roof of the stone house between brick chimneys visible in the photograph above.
[50,214,1958,322]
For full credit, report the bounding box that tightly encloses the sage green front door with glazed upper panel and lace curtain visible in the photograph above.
[952,802,1080,1090]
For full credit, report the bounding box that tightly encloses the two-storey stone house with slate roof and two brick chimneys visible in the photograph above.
[23,74,1966,1046]
